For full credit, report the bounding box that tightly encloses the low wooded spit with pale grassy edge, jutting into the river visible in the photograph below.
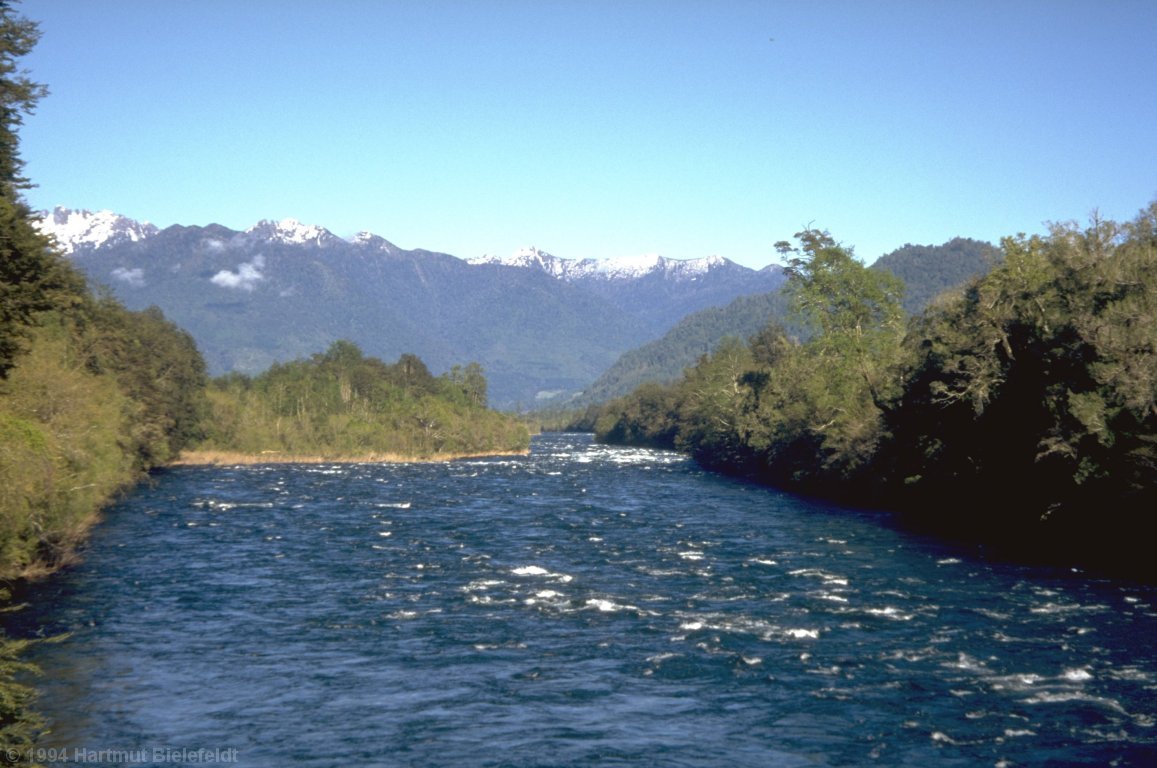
[192,341,530,461]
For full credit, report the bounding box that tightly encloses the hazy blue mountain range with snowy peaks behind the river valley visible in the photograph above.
[40,203,784,408]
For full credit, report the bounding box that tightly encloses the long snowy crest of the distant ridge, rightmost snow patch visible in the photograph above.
[467,246,738,282]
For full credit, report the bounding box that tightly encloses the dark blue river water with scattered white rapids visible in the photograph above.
[11,435,1157,768]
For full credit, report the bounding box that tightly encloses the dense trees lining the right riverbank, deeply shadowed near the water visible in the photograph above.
[596,210,1157,576]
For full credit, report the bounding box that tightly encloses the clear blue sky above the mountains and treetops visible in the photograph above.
[17,0,1157,267]
